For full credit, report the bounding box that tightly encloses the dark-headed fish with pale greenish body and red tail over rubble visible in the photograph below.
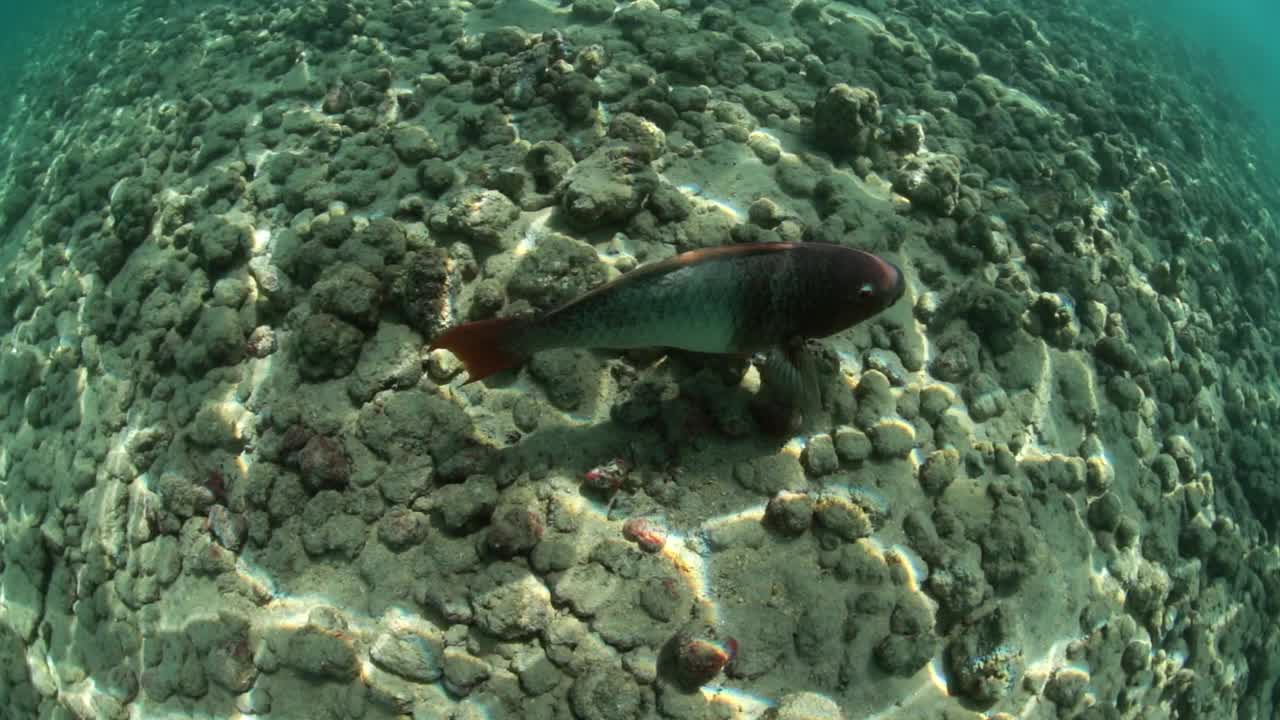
[429,242,906,383]
